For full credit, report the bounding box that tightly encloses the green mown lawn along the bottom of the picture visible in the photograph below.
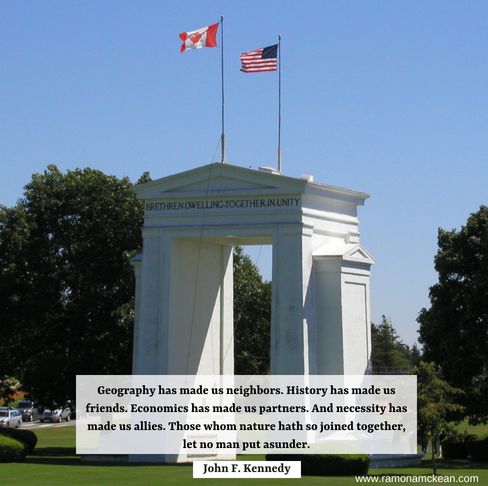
[0,426,488,486]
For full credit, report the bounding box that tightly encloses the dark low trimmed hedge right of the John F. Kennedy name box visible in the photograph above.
[266,454,369,476]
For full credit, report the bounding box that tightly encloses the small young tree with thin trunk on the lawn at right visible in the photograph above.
[415,361,463,474]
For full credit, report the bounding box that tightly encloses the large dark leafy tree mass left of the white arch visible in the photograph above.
[0,165,142,402]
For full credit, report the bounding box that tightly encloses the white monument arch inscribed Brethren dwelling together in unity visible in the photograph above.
[133,163,374,375]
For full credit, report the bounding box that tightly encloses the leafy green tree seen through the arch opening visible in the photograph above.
[234,246,271,375]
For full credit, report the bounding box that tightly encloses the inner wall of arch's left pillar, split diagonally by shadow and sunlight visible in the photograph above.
[166,238,234,375]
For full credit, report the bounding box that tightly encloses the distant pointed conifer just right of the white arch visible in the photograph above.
[371,316,418,374]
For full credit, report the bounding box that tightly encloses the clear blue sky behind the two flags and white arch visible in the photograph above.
[0,0,488,344]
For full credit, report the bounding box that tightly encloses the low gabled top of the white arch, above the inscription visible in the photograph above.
[133,162,370,203]
